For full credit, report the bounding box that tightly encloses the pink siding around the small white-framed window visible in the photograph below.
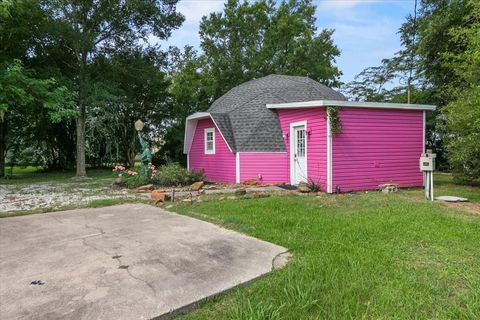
[189,119,236,183]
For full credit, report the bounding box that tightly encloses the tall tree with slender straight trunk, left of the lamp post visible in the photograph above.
[40,0,183,177]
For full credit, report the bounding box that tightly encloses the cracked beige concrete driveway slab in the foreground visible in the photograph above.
[0,204,286,319]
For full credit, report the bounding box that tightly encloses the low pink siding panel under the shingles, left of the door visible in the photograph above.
[240,152,290,183]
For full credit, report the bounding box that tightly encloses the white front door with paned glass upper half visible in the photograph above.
[290,124,307,185]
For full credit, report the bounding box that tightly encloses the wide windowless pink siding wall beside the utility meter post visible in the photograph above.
[332,108,423,191]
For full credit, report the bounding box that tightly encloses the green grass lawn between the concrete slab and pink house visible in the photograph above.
[172,176,480,320]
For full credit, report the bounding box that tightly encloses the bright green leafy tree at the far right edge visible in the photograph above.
[440,0,480,182]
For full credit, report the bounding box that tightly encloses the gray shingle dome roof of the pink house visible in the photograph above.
[207,75,346,152]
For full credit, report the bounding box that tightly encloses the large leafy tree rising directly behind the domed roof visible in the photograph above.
[200,0,340,98]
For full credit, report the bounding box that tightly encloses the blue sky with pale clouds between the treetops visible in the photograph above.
[162,0,414,83]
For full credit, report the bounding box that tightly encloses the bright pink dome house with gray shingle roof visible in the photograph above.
[184,75,435,193]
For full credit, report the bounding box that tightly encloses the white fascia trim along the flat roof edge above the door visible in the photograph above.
[266,100,436,110]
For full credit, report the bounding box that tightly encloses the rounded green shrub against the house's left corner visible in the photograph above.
[152,163,204,187]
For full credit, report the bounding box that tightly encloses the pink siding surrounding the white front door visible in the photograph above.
[277,108,327,190]
